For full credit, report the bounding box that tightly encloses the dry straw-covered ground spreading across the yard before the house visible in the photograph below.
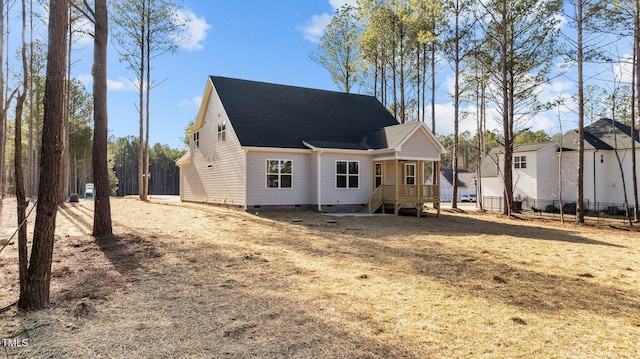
[0,199,640,358]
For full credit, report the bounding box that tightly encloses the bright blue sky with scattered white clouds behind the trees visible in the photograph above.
[10,0,630,148]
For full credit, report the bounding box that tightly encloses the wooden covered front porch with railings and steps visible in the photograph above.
[368,158,440,217]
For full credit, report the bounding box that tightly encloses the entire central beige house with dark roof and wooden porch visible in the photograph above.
[177,76,445,213]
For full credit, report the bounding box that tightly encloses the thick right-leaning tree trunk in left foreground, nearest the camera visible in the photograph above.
[19,0,69,310]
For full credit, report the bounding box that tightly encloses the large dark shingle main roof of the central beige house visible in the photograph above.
[210,76,398,149]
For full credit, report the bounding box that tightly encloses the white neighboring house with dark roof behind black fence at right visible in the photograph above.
[481,119,640,210]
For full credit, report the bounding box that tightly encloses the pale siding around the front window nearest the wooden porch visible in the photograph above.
[320,153,373,205]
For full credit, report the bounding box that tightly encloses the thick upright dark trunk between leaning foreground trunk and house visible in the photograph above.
[92,0,113,237]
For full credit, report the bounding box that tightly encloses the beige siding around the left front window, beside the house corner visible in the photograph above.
[247,151,315,206]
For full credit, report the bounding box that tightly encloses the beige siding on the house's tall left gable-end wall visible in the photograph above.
[182,86,245,206]
